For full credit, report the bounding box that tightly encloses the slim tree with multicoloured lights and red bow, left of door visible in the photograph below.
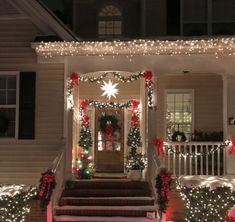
[76,100,93,179]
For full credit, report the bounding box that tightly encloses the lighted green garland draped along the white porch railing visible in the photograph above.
[165,141,230,158]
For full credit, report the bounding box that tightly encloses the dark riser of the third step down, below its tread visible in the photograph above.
[59,199,154,206]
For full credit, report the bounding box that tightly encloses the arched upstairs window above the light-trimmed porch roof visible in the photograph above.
[98,4,122,38]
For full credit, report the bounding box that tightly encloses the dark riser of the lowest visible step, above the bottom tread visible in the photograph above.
[56,210,147,217]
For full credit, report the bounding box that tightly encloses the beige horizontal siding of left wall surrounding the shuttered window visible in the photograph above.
[0,17,64,184]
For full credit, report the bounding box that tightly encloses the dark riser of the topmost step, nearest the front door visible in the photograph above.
[67,179,149,189]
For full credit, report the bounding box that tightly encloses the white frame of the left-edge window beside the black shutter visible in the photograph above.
[0,71,20,139]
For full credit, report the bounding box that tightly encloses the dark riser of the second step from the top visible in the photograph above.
[62,188,151,197]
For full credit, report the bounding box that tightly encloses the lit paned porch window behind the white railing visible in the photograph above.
[166,91,193,140]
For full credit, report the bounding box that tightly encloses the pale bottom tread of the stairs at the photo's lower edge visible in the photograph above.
[53,216,157,222]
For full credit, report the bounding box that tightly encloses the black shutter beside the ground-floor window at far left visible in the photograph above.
[19,72,36,139]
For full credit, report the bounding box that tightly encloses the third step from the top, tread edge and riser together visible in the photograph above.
[59,197,154,206]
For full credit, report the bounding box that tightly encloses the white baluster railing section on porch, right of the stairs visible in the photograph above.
[161,142,226,176]
